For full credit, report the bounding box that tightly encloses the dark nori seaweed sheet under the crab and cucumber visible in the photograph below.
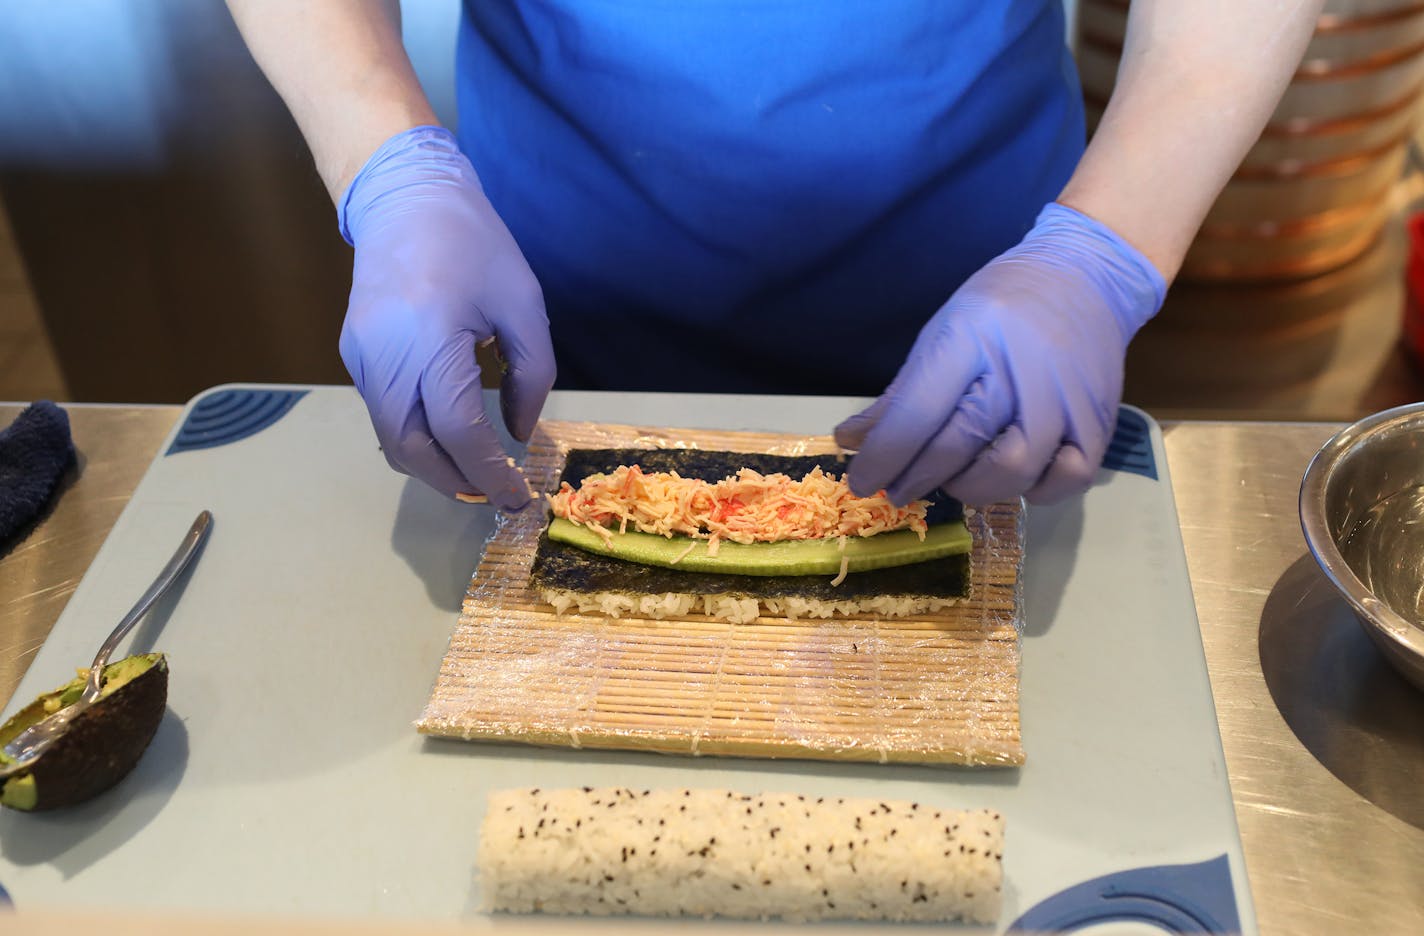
[531,449,970,601]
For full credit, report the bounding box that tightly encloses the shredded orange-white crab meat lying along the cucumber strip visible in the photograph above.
[548,464,928,544]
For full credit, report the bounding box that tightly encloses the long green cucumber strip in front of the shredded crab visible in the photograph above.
[548,517,974,576]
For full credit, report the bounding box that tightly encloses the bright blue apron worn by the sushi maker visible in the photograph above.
[457,0,1084,396]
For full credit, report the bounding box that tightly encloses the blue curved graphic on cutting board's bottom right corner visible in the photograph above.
[1007,855,1242,936]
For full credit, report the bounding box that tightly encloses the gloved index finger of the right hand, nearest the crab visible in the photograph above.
[846,326,985,497]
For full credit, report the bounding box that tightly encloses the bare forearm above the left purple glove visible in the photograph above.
[228,0,437,201]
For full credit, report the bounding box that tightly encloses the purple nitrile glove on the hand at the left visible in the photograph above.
[337,127,554,510]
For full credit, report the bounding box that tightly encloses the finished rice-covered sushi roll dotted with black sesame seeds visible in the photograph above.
[478,788,1004,923]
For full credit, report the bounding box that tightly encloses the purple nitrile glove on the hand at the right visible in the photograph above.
[836,204,1166,504]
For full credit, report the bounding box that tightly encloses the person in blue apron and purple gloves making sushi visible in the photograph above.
[229,0,1320,510]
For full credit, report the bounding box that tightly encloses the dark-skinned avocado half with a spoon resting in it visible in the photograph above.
[0,652,168,812]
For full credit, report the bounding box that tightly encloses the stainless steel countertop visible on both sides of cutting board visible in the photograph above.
[0,406,1424,933]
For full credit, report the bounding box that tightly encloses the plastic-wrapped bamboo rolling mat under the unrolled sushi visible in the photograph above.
[417,422,1024,765]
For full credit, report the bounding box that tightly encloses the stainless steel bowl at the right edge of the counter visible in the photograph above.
[1300,403,1424,690]
